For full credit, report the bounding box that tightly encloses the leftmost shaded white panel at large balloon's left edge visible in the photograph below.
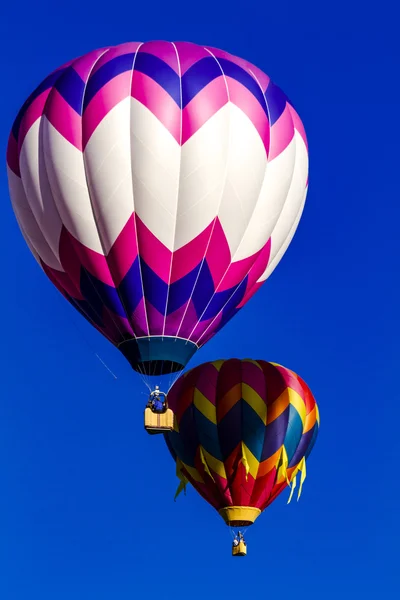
[7,167,63,271]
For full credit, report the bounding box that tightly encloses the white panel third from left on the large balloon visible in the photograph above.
[43,117,103,254]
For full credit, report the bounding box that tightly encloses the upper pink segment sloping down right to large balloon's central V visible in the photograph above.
[131,71,181,144]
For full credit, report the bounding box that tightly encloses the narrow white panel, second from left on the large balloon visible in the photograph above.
[19,119,62,259]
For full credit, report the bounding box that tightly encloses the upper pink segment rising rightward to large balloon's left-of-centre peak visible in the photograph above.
[82,71,131,148]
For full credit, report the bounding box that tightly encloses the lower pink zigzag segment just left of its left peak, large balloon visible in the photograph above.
[107,214,138,287]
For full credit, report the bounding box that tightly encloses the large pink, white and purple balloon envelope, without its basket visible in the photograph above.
[7,41,308,392]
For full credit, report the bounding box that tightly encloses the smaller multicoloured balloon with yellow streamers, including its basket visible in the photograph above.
[165,359,319,556]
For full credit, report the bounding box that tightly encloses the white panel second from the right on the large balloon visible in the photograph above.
[234,134,296,261]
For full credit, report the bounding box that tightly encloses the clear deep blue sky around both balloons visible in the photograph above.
[0,0,400,600]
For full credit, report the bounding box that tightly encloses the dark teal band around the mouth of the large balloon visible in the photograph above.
[118,335,198,377]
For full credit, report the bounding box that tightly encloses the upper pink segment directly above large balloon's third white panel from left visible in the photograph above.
[44,88,82,151]
